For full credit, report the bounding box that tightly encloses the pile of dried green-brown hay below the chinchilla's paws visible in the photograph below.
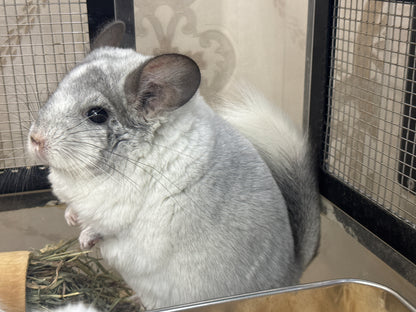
[26,239,143,311]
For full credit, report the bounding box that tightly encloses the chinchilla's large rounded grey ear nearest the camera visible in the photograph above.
[124,54,201,118]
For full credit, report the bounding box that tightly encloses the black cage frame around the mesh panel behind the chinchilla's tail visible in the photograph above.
[305,0,416,285]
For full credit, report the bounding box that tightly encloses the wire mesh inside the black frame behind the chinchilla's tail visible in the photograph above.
[324,0,416,226]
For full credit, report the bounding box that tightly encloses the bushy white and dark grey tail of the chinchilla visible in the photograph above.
[213,85,321,269]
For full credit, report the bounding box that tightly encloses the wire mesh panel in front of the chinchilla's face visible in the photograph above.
[0,0,89,170]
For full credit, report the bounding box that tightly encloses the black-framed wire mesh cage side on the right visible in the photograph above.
[307,0,416,284]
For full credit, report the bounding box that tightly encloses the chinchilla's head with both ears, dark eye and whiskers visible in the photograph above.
[28,22,200,174]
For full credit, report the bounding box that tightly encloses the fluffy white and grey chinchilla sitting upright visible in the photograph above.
[28,22,320,308]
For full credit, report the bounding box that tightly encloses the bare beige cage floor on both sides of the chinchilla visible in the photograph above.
[0,205,416,305]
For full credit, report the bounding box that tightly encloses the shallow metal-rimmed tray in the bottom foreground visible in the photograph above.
[154,279,416,312]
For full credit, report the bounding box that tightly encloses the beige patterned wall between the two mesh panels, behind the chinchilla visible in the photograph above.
[135,0,308,126]
